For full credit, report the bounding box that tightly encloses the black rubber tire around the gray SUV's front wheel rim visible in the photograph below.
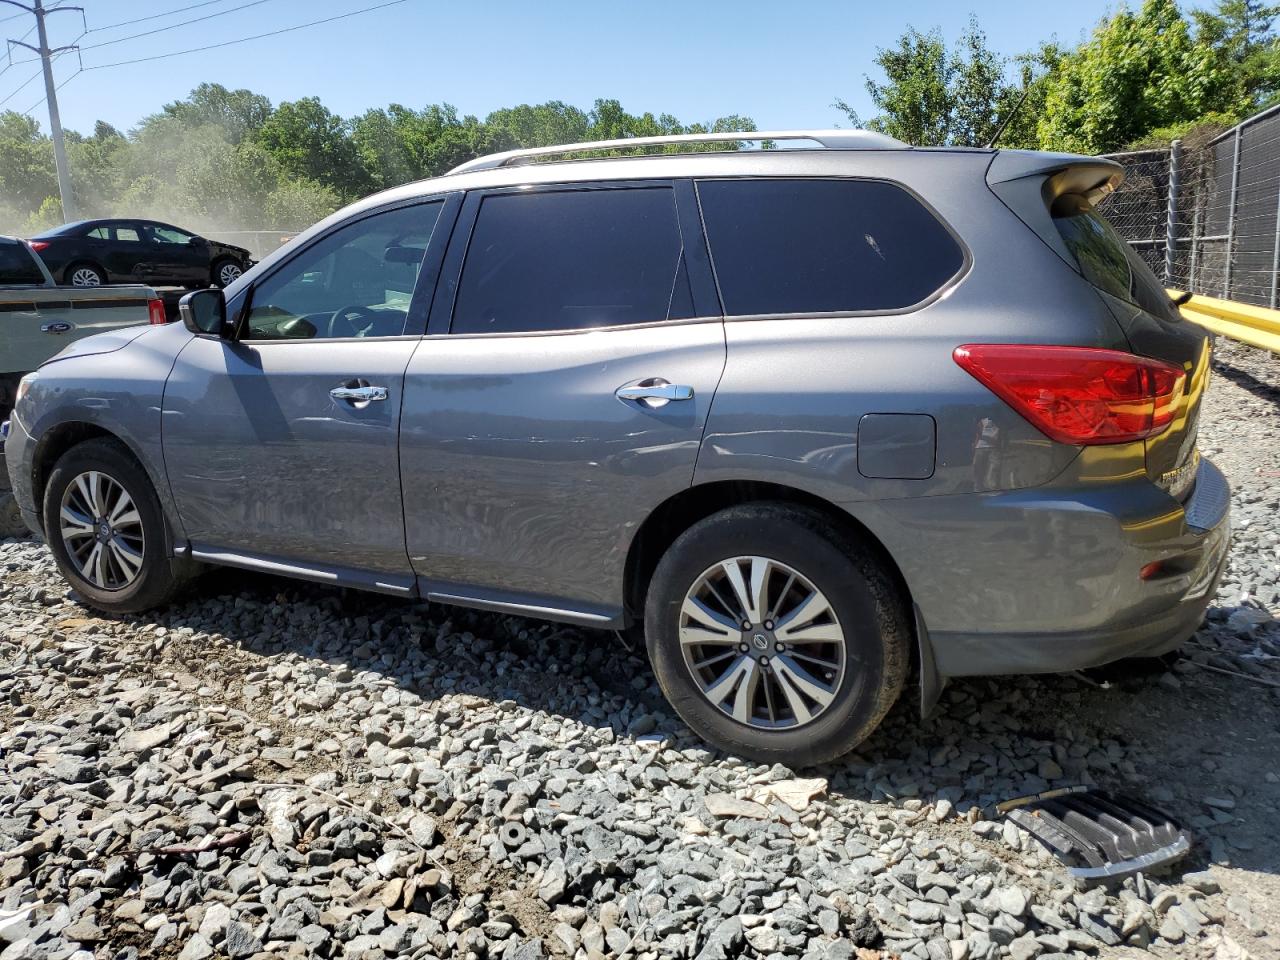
[42,438,189,613]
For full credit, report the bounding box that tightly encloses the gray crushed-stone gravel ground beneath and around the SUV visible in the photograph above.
[0,343,1280,960]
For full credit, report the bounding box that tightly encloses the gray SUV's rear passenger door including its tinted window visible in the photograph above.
[401,182,724,625]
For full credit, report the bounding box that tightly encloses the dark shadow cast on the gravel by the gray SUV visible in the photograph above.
[127,571,1280,896]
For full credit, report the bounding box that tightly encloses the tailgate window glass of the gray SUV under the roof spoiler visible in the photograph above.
[1052,196,1171,316]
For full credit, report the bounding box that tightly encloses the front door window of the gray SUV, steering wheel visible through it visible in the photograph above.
[244,202,442,340]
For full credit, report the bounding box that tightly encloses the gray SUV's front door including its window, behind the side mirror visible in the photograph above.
[164,200,458,593]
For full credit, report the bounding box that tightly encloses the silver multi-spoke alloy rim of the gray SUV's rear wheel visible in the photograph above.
[680,557,845,730]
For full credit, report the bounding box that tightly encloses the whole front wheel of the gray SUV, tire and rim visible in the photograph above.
[44,439,184,613]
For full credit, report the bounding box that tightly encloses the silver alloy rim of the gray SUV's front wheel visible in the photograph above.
[59,470,146,590]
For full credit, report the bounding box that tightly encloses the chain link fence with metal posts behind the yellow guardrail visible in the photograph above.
[1100,108,1280,307]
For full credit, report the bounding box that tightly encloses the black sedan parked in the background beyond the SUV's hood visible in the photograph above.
[31,220,253,287]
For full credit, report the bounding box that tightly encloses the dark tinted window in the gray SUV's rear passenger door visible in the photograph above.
[452,187,694,333]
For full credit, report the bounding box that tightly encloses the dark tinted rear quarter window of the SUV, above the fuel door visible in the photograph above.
[698,179,964,315]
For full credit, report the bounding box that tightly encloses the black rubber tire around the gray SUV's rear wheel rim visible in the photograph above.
[645,503,913,767]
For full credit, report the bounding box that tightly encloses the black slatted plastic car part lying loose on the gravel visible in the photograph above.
[996,786,1192,882]
